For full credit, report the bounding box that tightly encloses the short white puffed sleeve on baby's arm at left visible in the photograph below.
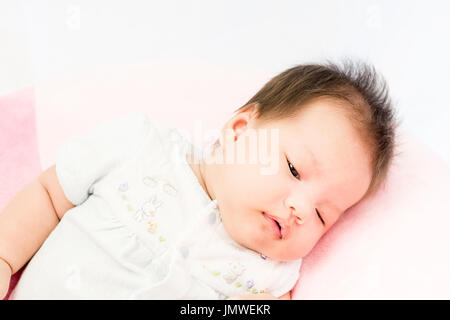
[56,113,155,205]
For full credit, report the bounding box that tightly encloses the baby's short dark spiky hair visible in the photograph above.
[235,60,398,198]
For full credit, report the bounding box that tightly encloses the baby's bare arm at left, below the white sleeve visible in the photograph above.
[0,165,74,299]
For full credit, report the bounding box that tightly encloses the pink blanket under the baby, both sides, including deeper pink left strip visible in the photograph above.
[0,66,450,299]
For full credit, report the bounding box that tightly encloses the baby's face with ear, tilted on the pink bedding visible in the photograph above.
[208,99,371,261]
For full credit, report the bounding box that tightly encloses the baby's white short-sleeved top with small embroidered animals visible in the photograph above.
[11,113,301,299]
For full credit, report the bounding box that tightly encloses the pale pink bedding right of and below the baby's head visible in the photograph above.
[293,132,450,299]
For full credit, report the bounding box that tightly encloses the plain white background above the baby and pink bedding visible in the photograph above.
[0,0,450,168]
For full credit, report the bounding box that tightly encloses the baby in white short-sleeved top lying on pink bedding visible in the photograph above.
[0,63,397,299]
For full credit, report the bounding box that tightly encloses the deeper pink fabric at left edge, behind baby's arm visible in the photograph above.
[0,88,41,299]
